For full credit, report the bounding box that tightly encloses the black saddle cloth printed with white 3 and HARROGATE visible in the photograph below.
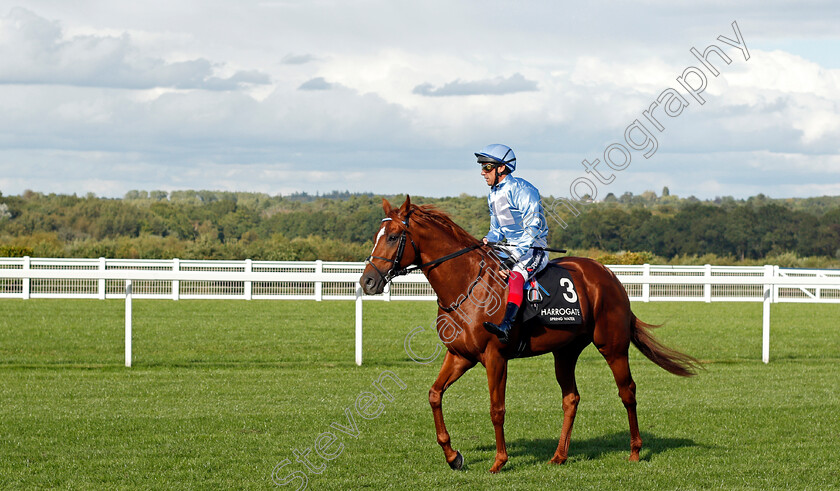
[522,263,583,326]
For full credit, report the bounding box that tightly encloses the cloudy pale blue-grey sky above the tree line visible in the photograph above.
[0,0,840,199]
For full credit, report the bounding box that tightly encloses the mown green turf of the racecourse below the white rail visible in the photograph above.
[0,300,840,489]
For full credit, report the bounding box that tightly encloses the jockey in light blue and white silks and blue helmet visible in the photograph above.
[475,144,548,344]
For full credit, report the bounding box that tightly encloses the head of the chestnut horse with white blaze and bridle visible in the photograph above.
[359,196,420,295]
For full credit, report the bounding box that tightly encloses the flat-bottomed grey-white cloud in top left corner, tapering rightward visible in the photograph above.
[0,7,270,90]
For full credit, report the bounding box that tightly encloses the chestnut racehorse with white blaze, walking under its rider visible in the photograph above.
[359,196,702,473]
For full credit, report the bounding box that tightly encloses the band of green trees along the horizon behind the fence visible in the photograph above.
[0,188,840,267]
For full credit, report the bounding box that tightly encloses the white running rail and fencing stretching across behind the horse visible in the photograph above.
[0,257,840,366]
